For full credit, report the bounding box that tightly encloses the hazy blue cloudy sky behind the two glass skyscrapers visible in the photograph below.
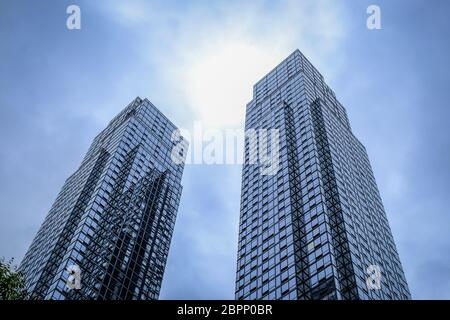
[0,0,450,299]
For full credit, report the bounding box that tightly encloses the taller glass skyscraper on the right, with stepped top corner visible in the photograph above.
[235,50,410,300]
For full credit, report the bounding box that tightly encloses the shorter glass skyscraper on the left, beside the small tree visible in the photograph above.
[20,97,187,299]
